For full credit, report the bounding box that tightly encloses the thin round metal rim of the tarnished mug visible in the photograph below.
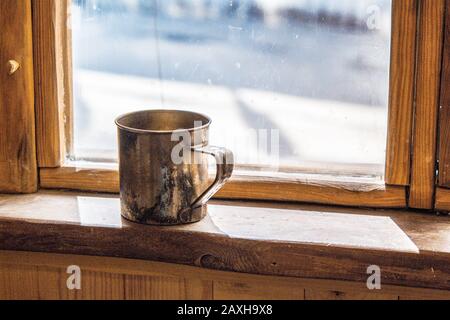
[114,109,212,134]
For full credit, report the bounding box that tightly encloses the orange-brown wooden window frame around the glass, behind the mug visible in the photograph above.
[2,0,448,210]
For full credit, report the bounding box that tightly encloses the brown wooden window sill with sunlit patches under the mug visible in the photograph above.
[0,191,450,290]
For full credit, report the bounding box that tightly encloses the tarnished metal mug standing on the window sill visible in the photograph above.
[116,110,234,225]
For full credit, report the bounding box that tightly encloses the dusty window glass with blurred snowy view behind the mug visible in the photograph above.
[71,0,391,175]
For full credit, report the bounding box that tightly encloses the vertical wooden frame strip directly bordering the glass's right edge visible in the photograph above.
[385,0,418,186]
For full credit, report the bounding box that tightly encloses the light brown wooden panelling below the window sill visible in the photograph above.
[0,251,450,300]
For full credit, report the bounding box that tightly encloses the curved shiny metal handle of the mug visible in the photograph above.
[191,146,234,209]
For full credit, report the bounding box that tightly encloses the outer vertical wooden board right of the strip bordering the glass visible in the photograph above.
[409,0,445,209]
